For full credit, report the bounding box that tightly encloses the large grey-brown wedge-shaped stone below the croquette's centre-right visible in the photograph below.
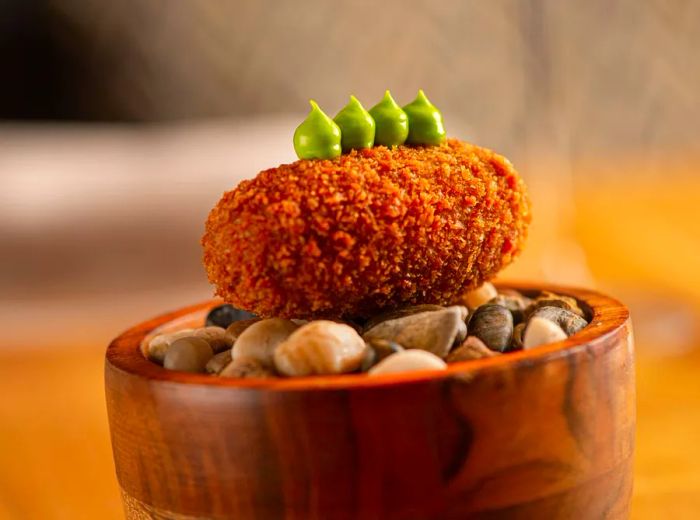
[363,305,467,358]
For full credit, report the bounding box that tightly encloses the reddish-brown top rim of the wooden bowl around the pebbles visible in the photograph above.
[105,282,629,391]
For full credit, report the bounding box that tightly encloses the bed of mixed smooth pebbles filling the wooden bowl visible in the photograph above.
[141,283,588,378]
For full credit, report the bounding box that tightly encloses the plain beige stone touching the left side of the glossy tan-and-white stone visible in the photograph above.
[232,318,299,367]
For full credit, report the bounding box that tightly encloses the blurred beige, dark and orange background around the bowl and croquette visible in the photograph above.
[0,0,700,519]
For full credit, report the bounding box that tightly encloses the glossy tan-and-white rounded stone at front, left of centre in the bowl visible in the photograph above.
[274,320,368,376]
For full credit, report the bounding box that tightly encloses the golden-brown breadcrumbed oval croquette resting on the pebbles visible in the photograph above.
[202,139,530,318]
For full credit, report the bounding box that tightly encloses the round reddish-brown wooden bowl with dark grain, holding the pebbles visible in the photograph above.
[105,284,635,520]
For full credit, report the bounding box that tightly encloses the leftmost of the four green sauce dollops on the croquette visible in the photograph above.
[294,100,341,159]
